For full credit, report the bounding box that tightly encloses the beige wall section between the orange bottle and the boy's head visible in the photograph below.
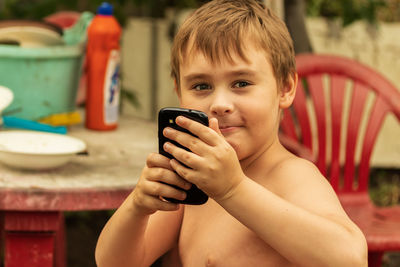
[121,18,178,119]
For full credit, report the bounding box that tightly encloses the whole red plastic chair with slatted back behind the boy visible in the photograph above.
[280,54,400,266]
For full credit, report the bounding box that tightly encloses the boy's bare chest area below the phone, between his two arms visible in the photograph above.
[179,199,294,267]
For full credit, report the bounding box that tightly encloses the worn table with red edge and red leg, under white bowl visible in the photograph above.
[0,116,157,267]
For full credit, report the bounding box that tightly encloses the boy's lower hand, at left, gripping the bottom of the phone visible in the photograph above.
[133,153,191,215]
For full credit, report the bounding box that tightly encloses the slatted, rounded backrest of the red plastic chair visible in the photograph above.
[280,54,400,196]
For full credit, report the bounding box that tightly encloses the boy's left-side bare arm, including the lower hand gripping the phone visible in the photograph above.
[96,154,190,267]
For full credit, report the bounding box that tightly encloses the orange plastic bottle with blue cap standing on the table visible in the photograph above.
[85,2,122,130]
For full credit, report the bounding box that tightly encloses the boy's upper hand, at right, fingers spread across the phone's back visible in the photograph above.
[164,116,245,201]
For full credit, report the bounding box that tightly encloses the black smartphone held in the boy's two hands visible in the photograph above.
[158,108,208,205]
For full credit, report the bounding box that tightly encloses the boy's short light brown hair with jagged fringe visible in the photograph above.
[171,0,296,89]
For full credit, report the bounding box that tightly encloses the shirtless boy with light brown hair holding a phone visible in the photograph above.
[96,0,367,267]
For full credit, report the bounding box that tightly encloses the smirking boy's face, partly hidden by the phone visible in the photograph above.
[178,46,296,160]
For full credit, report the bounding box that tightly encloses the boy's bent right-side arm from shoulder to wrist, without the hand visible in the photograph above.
[217,159,367,266]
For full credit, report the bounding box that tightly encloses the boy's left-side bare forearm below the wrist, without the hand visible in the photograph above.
[96,194,183,267]
